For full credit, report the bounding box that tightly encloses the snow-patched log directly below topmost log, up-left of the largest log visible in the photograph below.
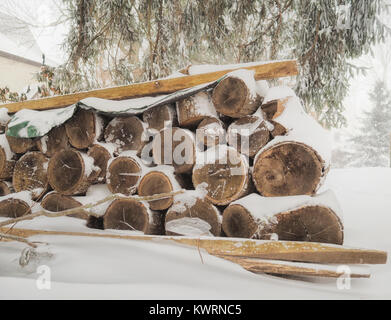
[227,112,270,158]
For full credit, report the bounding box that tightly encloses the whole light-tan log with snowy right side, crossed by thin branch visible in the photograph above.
[137,166,181,210]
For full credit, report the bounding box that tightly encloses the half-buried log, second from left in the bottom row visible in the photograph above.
[41,192,88,219]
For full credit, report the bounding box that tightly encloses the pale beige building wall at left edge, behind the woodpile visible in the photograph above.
[0,56,40,92]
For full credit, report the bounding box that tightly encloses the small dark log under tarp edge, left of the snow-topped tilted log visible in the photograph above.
[143,104,178,132]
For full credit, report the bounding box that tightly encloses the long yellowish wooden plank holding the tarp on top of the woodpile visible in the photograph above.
[2,60,298,113]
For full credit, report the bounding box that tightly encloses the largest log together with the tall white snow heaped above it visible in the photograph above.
[253,87,331,196]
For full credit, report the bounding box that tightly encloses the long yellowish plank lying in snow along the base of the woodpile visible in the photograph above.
[0,227,387,264]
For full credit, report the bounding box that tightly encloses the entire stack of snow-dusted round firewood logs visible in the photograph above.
[0,69,343,244]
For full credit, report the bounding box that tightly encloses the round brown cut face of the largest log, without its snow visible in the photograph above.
[253,142,323,197]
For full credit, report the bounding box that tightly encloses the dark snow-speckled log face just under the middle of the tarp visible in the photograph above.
[104,116,148,155]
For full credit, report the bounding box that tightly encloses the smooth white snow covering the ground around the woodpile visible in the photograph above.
[0,168,391,299]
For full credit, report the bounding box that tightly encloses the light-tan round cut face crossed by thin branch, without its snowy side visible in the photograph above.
[138,171,173,210]
